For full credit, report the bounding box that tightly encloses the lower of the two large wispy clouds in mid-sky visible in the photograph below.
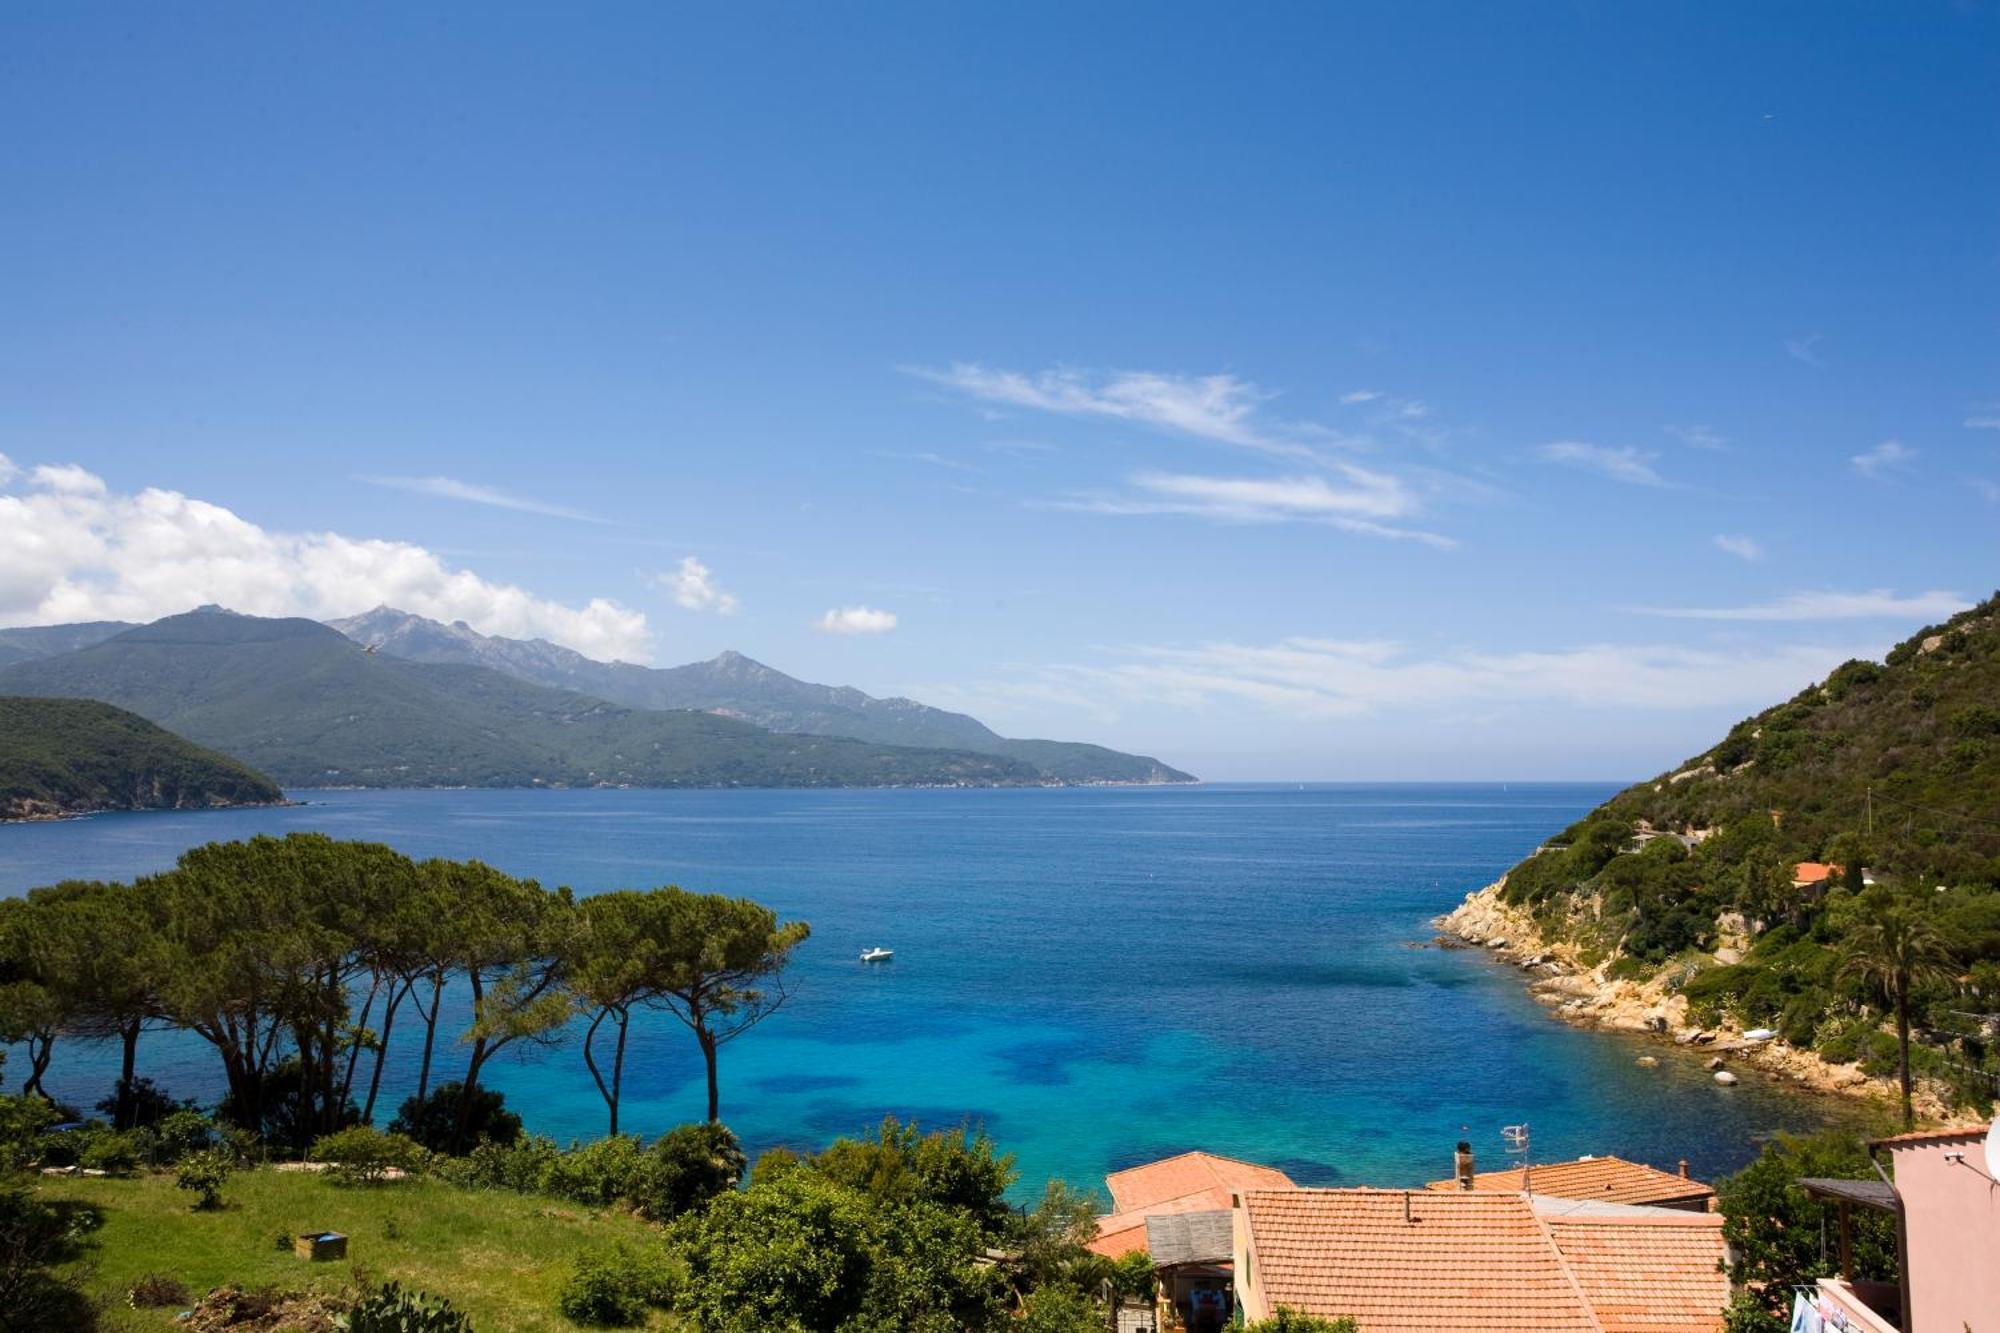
[1056,462,1456,546]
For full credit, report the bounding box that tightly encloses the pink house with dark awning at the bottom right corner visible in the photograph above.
[1800,1125,2000,1333]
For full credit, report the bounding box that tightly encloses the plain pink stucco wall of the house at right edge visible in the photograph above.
[1888,1133,2000,1333]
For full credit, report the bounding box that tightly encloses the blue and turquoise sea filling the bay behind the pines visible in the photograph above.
[0,785,1824,1187]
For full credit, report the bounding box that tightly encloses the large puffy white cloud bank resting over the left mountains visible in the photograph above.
[0,464,650,660]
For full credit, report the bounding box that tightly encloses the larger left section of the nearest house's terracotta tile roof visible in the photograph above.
[1244,1189,1600,1333]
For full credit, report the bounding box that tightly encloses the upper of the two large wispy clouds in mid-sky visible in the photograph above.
[910,362,1332,458]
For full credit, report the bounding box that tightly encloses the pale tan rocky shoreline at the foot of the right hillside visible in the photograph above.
[1432,879,1946,1119]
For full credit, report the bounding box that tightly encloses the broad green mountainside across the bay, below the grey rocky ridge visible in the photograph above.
[0,608,1040,787]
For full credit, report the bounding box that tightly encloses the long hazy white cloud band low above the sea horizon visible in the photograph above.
[958,636,1866,723]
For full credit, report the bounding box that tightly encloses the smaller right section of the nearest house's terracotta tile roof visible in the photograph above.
[1542,1213,1730,1333]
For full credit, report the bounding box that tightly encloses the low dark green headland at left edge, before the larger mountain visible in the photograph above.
[0,697,284,819]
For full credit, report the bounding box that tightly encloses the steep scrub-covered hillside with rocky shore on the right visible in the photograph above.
[1440,598,2000,1109]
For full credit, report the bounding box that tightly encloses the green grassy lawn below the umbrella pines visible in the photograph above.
[36,1171,664,1333]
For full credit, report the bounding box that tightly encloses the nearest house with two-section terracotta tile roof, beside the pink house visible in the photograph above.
[1234,1189,1730,1333]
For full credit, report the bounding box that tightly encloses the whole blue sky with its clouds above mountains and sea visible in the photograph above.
[0,2,2000,779]
